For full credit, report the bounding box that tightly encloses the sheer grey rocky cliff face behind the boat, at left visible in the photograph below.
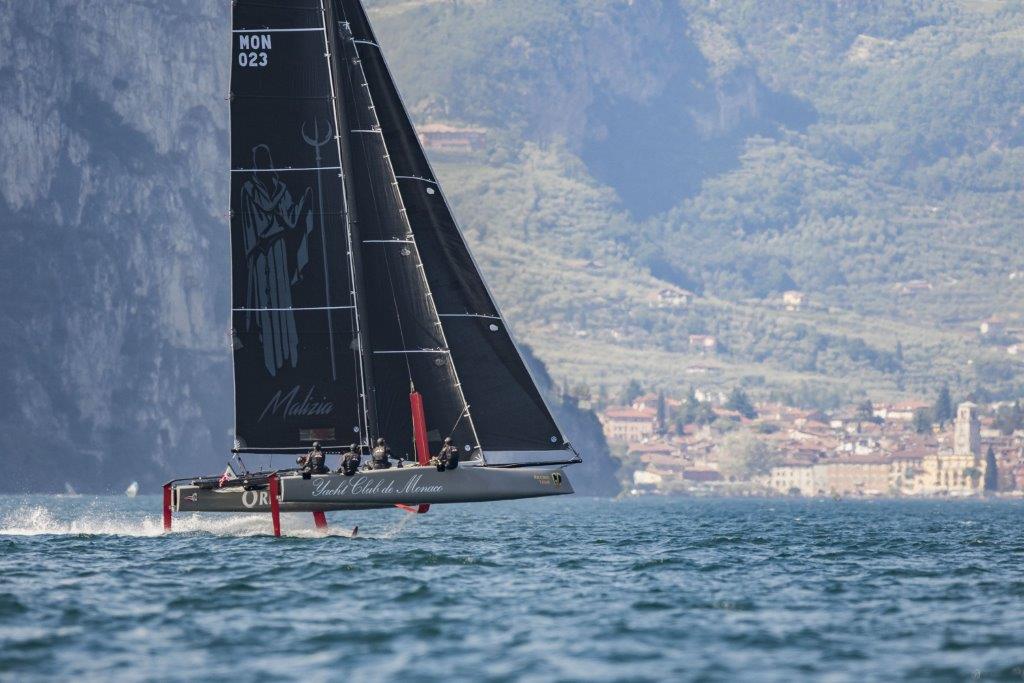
[0,0,611,493]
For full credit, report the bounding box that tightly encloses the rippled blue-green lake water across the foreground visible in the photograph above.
[0,497,1024,681]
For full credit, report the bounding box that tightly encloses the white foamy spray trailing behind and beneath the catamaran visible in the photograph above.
[0,506,368,539]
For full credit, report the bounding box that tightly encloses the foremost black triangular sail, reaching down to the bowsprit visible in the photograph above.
[333,0,567,462]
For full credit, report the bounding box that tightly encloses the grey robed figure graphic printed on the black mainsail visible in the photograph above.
[241,144,313,377]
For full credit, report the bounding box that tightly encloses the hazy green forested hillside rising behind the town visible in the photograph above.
[370,0,1024,403]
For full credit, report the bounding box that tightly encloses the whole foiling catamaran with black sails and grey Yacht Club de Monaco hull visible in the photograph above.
[164,0,581,535]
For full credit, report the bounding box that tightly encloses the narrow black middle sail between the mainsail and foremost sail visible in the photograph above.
[329,2,479,459]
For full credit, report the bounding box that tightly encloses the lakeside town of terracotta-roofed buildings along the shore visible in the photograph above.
[601,392,1024,497]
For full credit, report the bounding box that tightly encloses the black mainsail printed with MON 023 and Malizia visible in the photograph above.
[230,0,368,453]
